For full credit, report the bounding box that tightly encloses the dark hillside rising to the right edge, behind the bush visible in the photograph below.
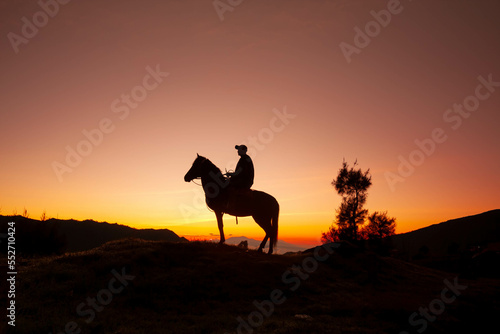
[391,210,500,278]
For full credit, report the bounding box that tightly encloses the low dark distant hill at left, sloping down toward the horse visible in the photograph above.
[0,216,187,255]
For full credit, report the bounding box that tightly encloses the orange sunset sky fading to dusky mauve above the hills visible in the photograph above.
[0,0,500,244]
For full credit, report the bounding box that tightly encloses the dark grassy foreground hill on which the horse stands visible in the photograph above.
[8,239,500,334]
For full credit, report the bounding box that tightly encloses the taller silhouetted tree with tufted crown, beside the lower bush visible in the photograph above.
[321,161,372,243]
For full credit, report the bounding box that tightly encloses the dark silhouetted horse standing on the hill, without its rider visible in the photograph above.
[184,154,280,254]
